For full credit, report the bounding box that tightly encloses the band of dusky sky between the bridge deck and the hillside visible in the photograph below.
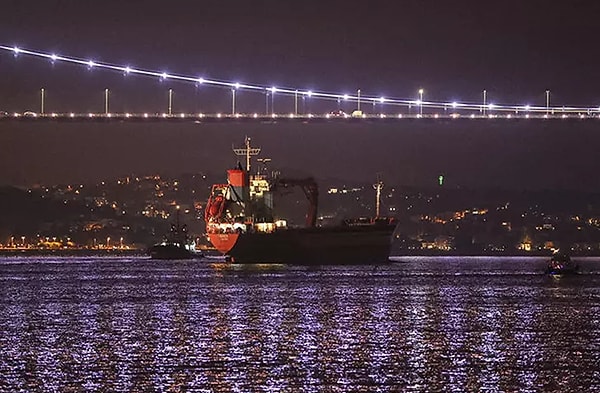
[0,119,600,191]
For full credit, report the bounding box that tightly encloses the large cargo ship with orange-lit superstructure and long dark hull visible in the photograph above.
[204,138,396,265]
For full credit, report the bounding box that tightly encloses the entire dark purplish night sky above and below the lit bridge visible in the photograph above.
[0,0,600,189]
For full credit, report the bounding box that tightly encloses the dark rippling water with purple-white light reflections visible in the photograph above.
[0,258,600,392]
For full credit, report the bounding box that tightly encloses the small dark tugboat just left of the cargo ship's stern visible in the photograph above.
[149,206,202,259]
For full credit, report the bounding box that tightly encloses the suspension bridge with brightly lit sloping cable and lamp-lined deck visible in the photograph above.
[0,45,600,122]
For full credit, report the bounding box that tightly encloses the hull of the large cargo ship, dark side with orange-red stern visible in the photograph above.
[208,224,395,265]
